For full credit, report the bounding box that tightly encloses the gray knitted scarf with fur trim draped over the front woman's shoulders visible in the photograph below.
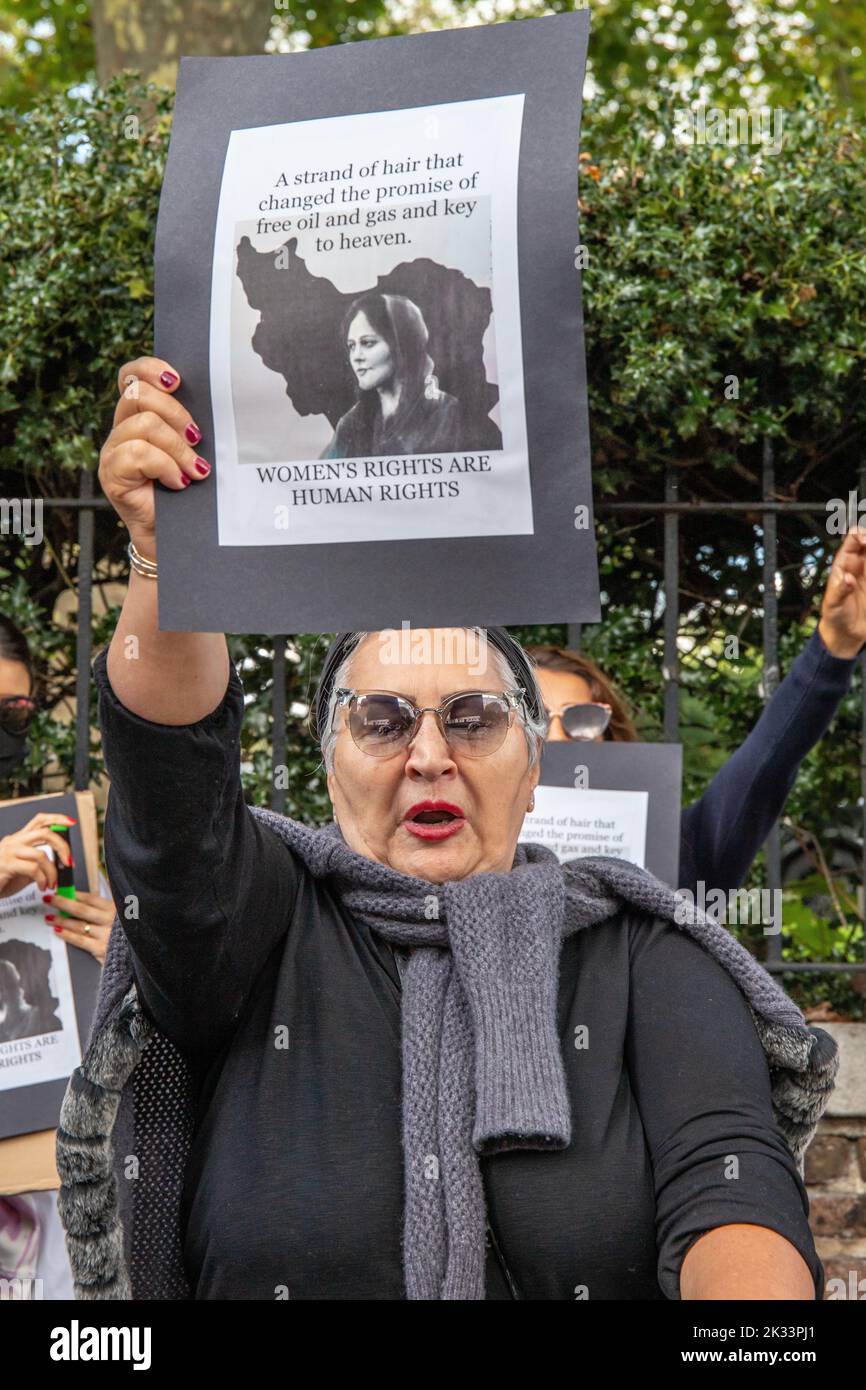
[57,806,838,1300]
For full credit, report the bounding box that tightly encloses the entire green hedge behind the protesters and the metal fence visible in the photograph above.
[0,75,866,1004]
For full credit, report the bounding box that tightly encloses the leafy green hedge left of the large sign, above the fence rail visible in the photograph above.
[0,78,172,478]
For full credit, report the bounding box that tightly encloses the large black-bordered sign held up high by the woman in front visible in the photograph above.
[150,10,601,632]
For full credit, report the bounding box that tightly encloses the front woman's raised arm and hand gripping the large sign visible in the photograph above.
[93,357,297,1054]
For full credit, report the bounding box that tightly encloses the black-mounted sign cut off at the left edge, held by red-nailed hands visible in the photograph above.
[0,792,101,1140]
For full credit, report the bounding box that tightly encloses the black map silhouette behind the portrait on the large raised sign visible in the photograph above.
[238,236,502,452]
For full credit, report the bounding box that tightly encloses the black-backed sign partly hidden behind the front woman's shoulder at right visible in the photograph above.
[520,741,683,888]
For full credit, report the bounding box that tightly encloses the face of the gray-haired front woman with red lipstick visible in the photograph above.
[328,631,539,883]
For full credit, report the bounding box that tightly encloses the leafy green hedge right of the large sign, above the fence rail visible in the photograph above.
[581,78,866,500]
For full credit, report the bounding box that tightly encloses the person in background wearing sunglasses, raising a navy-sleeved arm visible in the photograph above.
[527,527,866,894]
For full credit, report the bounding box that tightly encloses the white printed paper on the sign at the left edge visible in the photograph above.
[0,845,81,1091]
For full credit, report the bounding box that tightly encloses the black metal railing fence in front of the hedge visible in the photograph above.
[43,455,866,973]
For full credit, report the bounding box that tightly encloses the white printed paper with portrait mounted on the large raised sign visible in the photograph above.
[210,93,534,546]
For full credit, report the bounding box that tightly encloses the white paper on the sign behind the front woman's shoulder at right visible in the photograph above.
[518,787,649,869]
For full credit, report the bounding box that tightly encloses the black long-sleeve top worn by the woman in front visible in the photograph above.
[93,651,824,1300]
